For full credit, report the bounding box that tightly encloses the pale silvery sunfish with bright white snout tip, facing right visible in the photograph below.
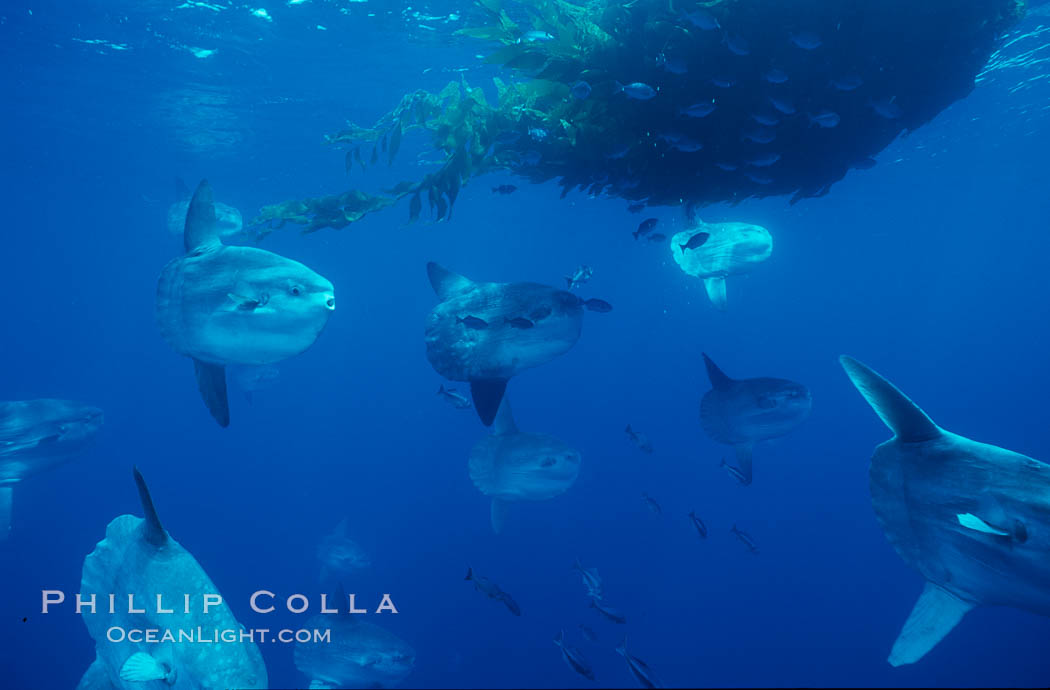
[156,181,335,426]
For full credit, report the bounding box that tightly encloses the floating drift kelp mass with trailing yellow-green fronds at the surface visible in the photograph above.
[254,0,1024,232]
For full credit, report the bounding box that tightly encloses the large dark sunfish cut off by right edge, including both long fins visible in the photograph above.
[840,356,1050,666]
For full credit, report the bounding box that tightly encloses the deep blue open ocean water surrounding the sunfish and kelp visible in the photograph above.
[0,0,1050,688]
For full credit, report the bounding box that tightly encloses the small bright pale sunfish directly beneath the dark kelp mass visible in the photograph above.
[671,217,773,309]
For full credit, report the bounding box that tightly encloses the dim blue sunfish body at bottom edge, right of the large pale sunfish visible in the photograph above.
[295,611,416,688]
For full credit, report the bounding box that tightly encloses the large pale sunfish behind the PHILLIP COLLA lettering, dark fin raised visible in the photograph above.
[77,469,267,690]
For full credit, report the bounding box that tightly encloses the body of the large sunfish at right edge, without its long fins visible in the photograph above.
[868,431,1050,615]
